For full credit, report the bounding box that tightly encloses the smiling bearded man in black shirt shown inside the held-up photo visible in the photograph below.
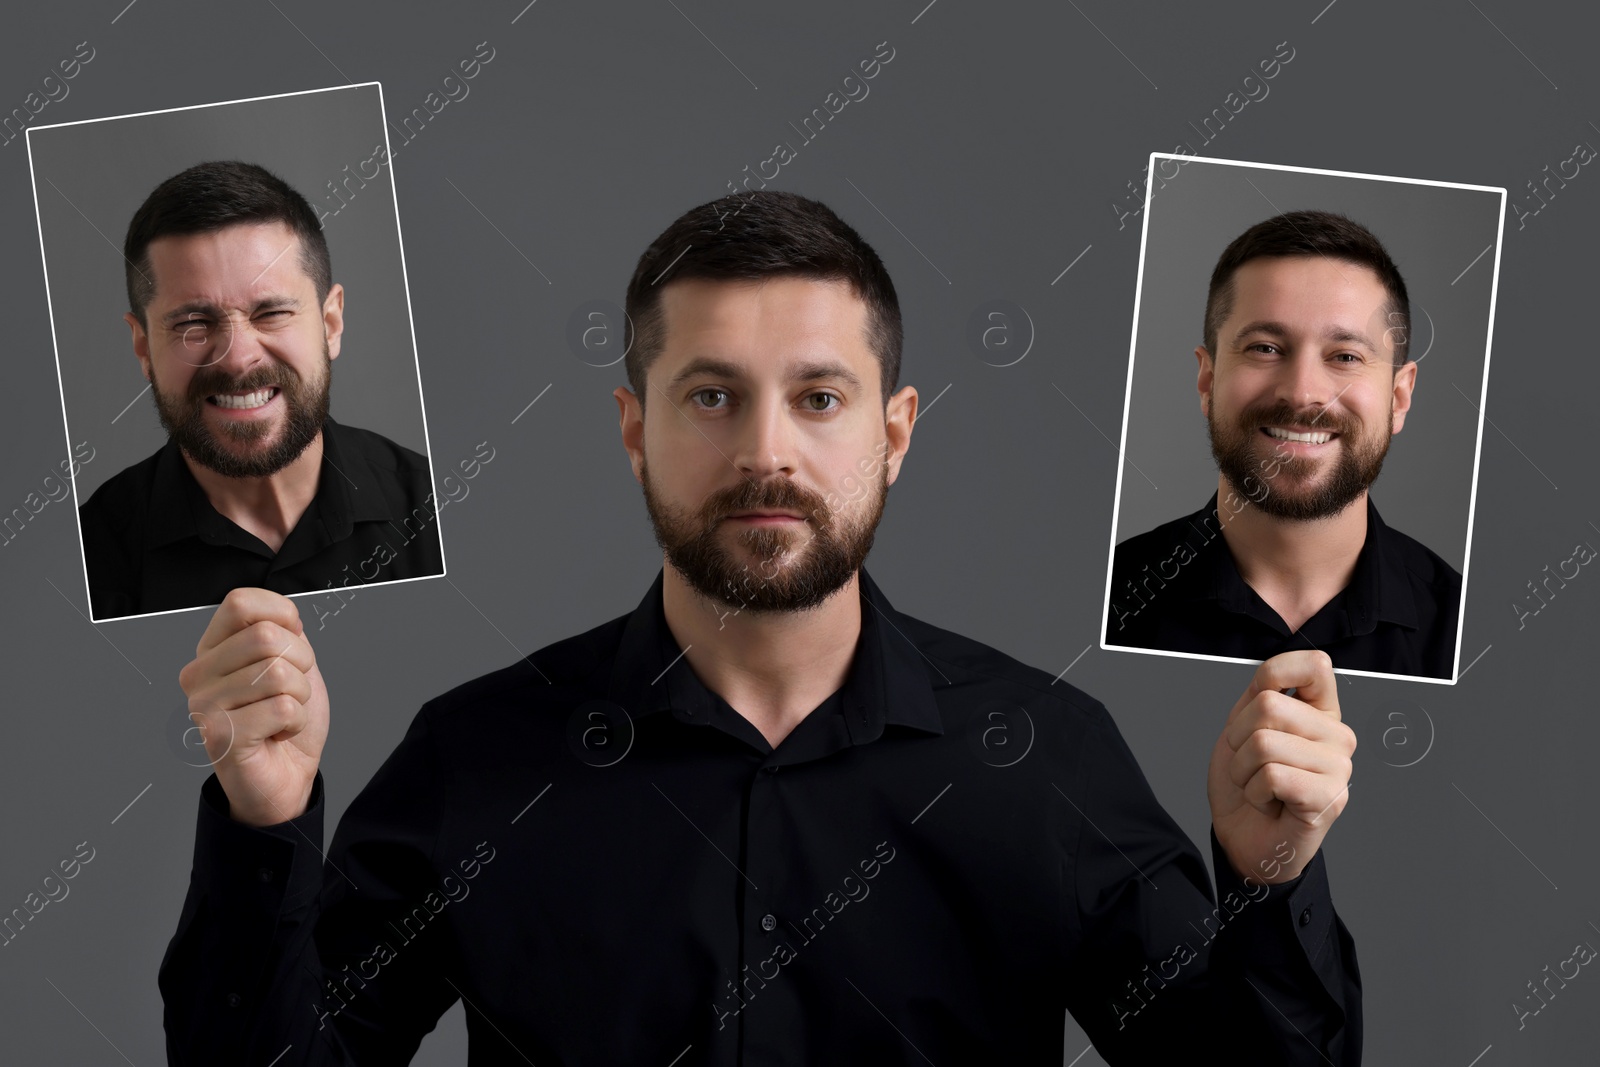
[1106,211,1461,678]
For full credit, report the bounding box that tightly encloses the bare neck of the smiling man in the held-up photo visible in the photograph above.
[1218,478,1366,630]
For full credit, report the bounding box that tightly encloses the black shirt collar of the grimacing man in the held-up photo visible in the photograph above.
[147,416,393,549]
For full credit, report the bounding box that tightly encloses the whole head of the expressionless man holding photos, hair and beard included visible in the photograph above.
[616,192,917,611]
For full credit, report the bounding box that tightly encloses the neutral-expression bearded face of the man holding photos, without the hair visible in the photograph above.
[616,277,917,611]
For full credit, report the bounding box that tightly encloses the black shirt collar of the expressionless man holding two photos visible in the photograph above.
[606,568,944,744]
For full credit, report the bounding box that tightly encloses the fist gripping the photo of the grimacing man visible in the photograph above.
[178,589,328,825]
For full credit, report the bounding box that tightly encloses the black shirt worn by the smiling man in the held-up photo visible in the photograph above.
[1106,493,1461,678]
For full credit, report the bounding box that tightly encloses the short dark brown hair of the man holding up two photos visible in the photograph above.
[624,190,904,408]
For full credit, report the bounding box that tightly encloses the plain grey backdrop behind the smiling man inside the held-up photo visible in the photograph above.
[1115,156,1501,571]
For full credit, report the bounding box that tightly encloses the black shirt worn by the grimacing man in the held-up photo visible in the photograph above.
[78,418,445,621]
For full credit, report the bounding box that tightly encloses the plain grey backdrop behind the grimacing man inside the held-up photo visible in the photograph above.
[31,81,427,502]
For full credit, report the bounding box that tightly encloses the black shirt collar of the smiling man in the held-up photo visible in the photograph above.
[1189,493,1419,637]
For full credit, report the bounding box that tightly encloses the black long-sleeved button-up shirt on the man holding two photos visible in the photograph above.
[160,571,1362,1067]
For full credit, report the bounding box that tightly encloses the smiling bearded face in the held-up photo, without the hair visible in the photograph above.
[1195,256,1416,522]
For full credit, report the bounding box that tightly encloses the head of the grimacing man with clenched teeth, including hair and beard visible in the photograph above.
[123,162,344,478]
